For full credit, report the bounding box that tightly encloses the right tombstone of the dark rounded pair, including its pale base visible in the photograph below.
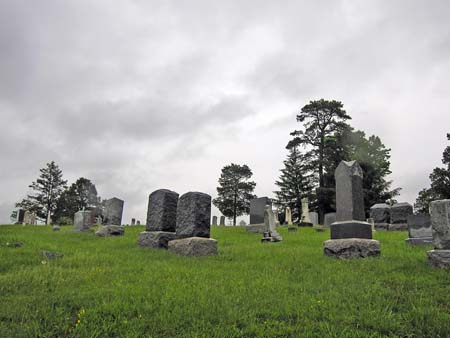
[168,192,217,256]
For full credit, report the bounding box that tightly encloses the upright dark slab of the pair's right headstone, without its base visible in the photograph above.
[176,192,211,238]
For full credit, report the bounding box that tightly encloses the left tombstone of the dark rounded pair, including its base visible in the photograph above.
[138,189,178,249]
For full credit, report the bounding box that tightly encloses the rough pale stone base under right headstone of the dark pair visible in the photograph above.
[168,237,218,256]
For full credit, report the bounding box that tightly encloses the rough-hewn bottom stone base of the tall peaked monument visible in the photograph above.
[323,238,381,259]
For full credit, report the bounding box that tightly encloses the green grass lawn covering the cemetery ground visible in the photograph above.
[0,226,450,338]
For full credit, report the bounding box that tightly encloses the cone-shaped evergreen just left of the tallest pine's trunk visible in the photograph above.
[274,146,315,223]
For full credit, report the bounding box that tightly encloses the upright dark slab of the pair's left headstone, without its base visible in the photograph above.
[146,189,178,232]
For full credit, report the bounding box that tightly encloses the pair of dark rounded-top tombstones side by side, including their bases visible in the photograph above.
[138,189,217,256]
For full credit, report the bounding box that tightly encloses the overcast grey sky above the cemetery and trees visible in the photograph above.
[0,0,450,223]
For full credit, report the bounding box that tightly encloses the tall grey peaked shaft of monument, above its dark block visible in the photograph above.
[335,161,366,222]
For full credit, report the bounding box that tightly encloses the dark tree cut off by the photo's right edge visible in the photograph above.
[414,134,450,213]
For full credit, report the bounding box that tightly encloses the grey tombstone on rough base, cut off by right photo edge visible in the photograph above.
[427,200,450,269]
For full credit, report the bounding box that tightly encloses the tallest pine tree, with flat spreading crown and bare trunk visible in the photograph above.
[288,99,351,221]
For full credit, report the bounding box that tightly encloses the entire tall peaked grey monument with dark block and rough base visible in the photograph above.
[324,161,380,258]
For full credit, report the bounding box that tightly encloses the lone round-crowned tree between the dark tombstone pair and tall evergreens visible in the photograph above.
[213,163,256,225]
